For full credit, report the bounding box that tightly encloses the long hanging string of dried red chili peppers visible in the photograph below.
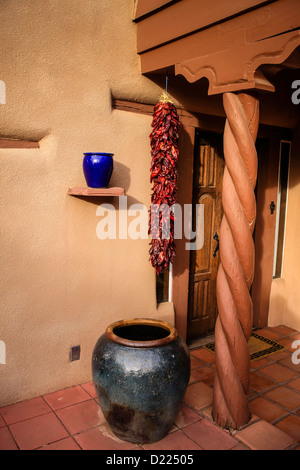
[149,87,180,274]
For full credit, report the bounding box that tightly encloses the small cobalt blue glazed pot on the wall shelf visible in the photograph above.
[83,152,113,188]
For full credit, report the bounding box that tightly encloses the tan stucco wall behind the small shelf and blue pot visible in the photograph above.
[0,0,173,406]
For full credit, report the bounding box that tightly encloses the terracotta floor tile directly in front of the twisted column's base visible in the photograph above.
[183,419,237,450]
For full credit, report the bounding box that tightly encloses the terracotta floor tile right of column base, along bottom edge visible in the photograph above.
[235,421,295,450]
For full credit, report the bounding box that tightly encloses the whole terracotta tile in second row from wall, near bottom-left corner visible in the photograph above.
[10,412,68,450]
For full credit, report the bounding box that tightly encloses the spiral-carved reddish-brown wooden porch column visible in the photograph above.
[213,93,259,429]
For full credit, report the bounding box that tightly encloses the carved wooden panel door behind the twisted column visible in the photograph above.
[187,129,224,339]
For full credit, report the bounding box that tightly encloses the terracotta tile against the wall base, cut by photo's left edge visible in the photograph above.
[0,397,52,424]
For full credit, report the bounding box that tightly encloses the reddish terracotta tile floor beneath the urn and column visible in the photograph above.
[0,325,300,451]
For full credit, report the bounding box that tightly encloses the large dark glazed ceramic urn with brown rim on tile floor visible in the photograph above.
[92,319,190,444]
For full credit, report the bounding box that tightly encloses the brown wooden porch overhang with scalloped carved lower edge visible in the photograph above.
[137,0,300,95]
